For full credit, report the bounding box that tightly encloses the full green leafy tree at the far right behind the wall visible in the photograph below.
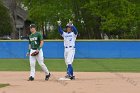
[86,0,136,38]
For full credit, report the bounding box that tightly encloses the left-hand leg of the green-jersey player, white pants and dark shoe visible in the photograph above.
[29,50,36,80]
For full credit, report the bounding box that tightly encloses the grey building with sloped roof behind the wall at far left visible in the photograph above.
[2,0,27,39]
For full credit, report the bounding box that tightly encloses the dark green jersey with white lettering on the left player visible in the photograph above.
[29,32,43,49]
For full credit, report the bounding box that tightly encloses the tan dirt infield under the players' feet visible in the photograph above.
[0,72,140,93]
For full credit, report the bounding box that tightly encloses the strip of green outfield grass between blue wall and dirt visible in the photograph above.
[0,59,140,72]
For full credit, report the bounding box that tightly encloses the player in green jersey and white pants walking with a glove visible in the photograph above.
[27,24,50,81]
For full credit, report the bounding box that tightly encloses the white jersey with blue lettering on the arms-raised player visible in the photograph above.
[62,32,77,47]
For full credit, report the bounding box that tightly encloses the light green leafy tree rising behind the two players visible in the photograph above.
[23,0,72,38]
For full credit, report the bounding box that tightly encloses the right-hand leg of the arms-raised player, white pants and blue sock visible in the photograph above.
[67,49,75,76]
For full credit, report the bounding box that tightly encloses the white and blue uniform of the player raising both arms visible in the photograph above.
[58,25,78,76]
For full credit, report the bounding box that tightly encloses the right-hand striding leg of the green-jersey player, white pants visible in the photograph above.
[36,49,50,80]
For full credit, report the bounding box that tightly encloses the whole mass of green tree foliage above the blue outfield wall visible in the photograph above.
[23,0,140,39]
